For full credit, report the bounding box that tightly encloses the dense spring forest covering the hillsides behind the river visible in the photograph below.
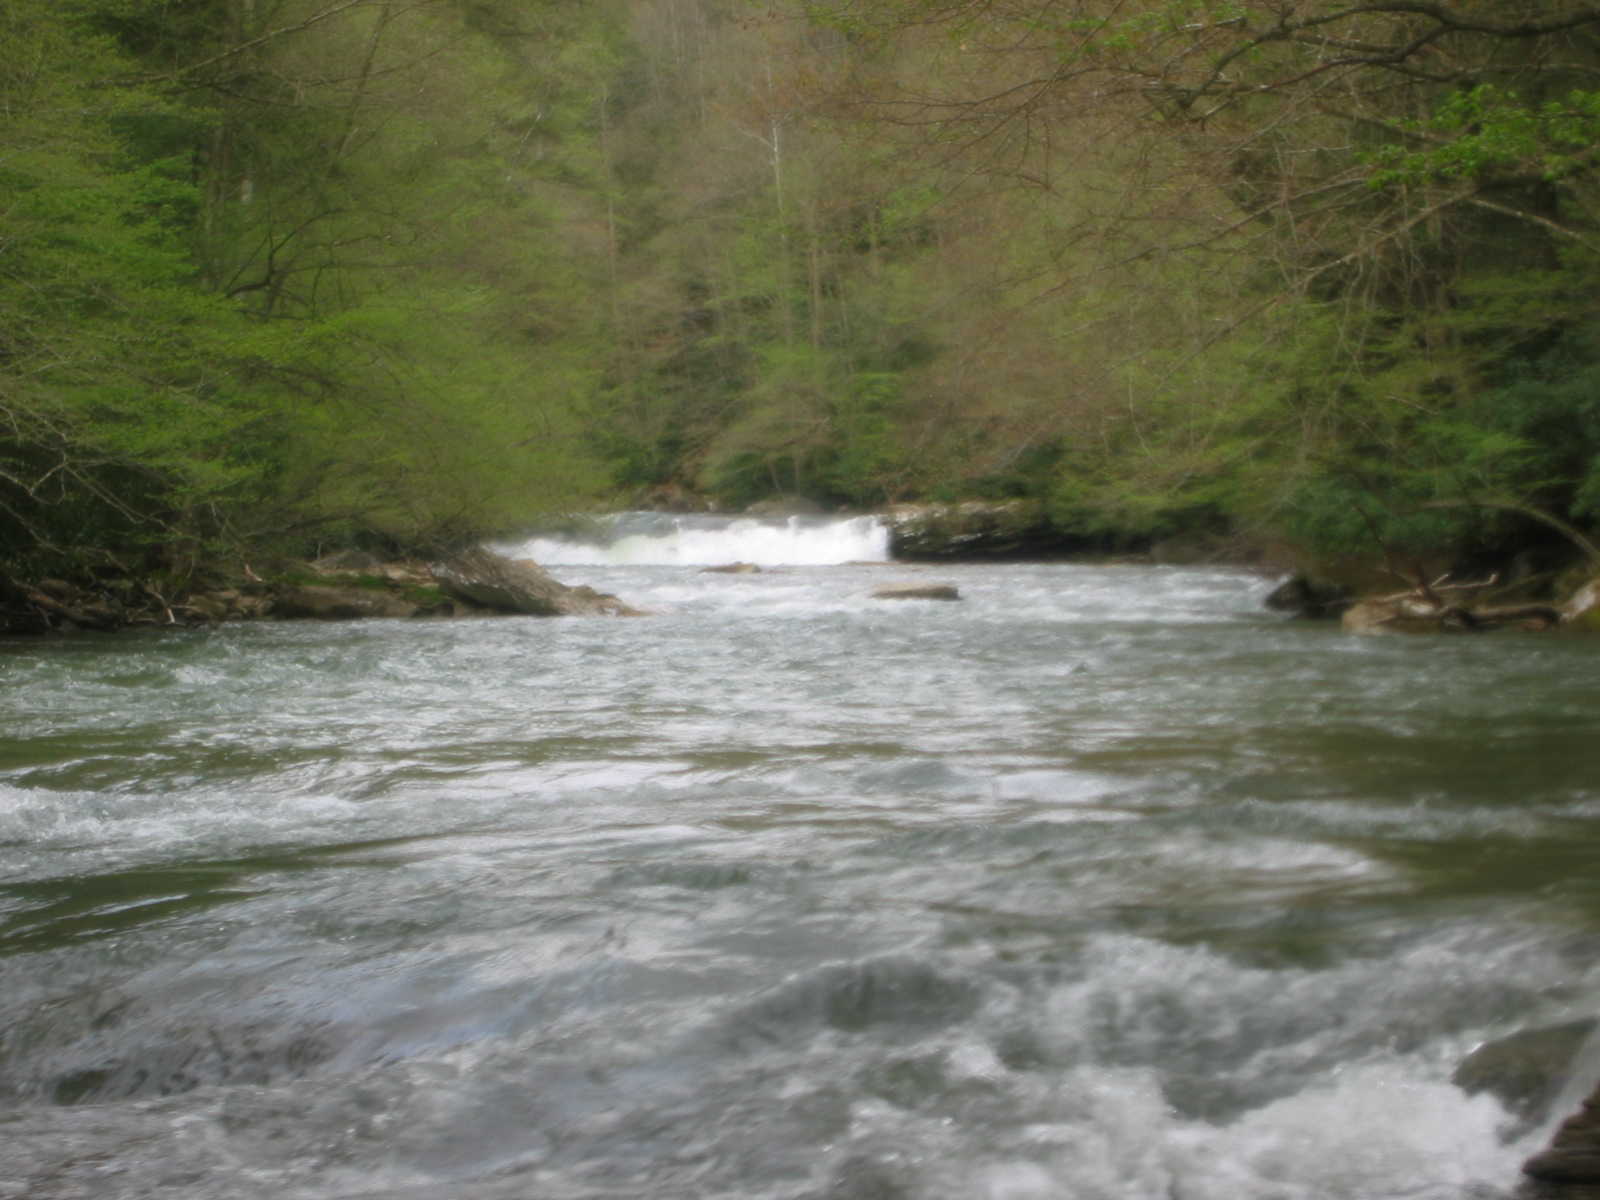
[9,0,1600,589]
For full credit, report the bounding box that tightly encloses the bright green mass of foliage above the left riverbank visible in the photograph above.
[0,0,624,582]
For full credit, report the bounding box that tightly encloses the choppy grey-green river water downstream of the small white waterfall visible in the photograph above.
[0,530,1600,1200]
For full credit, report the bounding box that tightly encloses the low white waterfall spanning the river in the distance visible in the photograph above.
[493,512,890,566]
